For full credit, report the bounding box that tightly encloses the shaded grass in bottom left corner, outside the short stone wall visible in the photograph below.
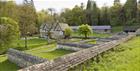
[0,55,19,71]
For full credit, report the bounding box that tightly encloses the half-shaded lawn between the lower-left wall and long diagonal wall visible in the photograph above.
[26,44,73,60]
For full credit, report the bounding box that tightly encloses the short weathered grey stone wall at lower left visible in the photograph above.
[7,48,47,68]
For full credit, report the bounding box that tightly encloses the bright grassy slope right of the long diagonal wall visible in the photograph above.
[71,37,140,71]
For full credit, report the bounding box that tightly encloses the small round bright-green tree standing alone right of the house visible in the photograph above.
[78,24,92,39]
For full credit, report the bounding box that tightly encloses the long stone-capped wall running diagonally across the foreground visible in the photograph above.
[19,34,136,71]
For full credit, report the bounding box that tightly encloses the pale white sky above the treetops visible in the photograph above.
[16,0,126,12]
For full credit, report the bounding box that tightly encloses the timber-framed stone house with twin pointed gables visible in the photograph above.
[40,23,69,39]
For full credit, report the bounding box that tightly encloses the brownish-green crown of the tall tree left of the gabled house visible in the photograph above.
[18,4,37,37]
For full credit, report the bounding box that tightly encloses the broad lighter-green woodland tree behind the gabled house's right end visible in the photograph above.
[61,5,86,26]
